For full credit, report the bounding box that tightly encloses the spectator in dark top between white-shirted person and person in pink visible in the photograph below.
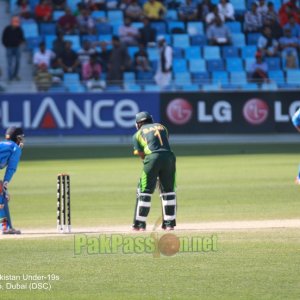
[59,41,80,73]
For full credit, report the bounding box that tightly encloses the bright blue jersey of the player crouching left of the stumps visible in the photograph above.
[0,141,22,182]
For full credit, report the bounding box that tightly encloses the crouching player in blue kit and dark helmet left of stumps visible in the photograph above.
[0,127,24,234]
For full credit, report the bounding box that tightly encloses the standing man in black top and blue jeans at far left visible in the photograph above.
[2,16,25,81]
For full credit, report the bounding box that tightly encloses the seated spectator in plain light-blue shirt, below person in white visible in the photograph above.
[206,17,231,46]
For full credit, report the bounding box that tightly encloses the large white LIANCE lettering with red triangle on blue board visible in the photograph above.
[1,97,139,129]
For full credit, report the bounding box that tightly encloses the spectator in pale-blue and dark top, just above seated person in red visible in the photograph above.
[257,26,279,57]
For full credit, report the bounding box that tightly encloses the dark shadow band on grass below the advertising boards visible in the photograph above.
[22,143,300,160]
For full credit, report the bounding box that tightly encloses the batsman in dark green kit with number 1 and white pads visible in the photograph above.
[132,112,176,231]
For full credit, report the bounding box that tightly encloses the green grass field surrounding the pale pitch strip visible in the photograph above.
[0,144,300,299]
